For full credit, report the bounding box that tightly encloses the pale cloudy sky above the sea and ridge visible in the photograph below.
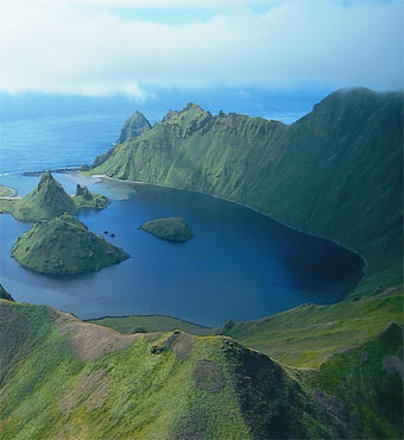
[0,0,404,100]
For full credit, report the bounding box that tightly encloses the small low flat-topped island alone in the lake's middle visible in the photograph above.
[140,217,194,242]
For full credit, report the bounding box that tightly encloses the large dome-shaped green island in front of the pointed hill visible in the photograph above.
[12,214,129,275]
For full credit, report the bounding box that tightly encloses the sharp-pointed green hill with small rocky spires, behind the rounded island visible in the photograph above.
[0,171,109,221]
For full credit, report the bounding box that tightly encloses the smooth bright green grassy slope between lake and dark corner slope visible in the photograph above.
[226,293,404,368]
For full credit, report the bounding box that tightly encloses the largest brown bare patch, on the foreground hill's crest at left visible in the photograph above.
[56,313,140,362]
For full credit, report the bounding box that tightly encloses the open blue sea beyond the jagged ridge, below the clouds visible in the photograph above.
[0,89,329,174]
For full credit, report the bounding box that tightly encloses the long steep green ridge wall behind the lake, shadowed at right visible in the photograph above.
[91,89,403,292]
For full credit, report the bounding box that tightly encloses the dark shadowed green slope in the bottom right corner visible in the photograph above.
[303,325,404,439]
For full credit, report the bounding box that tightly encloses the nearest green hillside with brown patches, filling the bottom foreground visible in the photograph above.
[0,301,356,440]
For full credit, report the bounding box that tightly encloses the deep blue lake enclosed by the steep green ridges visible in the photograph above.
[0,174,361,325]
